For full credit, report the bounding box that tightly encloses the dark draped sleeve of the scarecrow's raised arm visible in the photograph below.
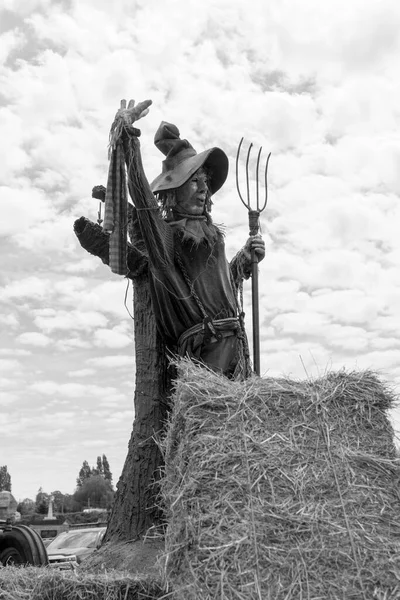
[122,126,174,269]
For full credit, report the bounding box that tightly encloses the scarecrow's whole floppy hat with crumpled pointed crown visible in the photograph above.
[151,121,229,194]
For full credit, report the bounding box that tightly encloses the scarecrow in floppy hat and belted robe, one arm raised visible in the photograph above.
[103,100,265,379]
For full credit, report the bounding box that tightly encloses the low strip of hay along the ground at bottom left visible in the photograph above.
[0,567,165,600]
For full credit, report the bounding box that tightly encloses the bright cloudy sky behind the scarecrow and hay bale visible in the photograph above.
[0,0,400,499]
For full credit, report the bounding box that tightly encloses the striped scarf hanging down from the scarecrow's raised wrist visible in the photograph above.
[103,136,128,275]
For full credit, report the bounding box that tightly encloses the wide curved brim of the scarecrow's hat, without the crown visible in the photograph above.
[150,148,229,194]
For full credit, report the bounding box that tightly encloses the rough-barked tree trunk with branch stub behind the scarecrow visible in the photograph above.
[74,217,171,542]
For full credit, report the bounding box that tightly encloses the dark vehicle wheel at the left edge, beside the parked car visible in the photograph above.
[0,525,48,567]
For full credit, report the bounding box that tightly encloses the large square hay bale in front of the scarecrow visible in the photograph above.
[162,361,400,600]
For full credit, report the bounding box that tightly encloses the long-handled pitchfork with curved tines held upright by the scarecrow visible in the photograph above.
[236,138,271,375]
